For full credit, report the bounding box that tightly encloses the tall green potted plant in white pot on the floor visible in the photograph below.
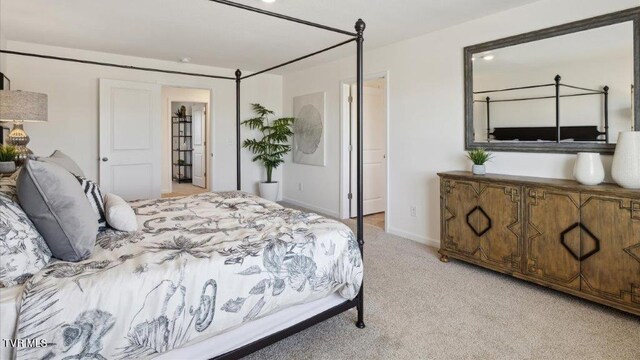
[242,104,295,201]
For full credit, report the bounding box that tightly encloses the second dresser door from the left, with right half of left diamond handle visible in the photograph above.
[472,183,522,272]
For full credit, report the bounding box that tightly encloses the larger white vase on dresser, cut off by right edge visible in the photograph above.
[611,131,640,189]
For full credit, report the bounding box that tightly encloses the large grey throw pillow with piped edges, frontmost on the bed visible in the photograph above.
[17,161,98,261]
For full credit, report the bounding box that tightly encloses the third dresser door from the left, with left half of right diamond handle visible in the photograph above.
[524,187,581,290]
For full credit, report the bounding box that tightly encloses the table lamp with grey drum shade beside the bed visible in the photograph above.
[0,90,47,163]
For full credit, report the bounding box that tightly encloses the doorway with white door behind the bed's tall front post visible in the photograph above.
[343,74,388,230]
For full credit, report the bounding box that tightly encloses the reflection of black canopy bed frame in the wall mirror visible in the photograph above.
[473,75,609,144]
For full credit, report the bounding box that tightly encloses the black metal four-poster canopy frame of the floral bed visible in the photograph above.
[0,0,366,360]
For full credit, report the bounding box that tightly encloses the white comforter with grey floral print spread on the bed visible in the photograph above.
[17,192,363,359]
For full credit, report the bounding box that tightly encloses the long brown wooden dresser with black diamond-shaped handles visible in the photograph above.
[438,171,640,315]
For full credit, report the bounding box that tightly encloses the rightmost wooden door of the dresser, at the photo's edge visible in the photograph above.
[581,193,640,308]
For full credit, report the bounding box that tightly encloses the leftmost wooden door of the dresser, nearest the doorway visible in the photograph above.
[440,179,480,258]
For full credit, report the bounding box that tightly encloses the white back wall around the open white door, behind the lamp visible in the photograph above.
[7,41,282,192]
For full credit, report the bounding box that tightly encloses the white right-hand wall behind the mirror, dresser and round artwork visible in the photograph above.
[284,0,638,245]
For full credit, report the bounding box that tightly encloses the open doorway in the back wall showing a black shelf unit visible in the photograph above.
[162,87,211,197]
